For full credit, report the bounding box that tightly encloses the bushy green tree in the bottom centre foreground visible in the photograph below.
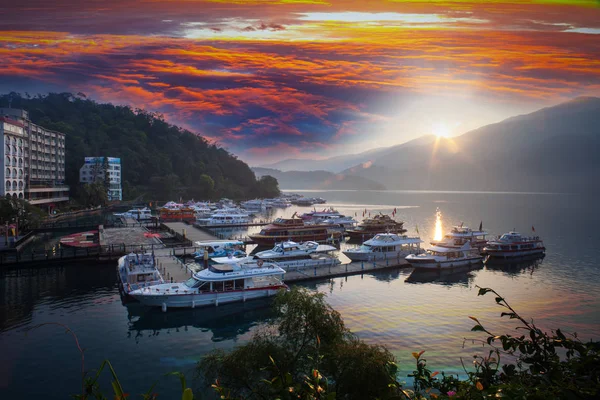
[198,287,397,399]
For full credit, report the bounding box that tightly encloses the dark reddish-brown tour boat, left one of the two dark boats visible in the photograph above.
[249,215,341,246]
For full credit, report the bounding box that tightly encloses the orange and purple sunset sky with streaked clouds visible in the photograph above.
[0,0,600,165]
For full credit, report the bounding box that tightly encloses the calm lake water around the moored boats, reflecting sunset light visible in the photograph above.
[0,191,600,399]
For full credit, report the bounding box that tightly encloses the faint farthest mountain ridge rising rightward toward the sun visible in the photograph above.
[259,135,435,173]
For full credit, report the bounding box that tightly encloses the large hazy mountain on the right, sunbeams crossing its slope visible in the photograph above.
[344,97,600,192]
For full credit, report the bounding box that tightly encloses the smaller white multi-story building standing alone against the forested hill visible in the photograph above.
[79,157,123,201]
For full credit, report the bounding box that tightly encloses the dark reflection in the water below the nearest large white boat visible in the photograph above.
[126,298,274,342]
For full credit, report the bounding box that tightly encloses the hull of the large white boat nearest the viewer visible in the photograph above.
[131,285,287,308]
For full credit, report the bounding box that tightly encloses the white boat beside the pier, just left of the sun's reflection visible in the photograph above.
[343,233,423,261]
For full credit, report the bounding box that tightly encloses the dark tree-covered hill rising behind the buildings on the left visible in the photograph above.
[0,93,279,200]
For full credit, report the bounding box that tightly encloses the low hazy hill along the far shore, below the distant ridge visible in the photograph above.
[252,167,385,190]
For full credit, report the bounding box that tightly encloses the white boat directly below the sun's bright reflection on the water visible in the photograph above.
[405,242,483,269]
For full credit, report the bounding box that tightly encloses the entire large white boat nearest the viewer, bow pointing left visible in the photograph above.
[130,261,287,311]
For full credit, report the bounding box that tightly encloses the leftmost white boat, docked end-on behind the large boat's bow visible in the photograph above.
[117,253,165,294]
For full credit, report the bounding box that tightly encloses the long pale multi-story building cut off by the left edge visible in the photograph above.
[0,108,69,206]
